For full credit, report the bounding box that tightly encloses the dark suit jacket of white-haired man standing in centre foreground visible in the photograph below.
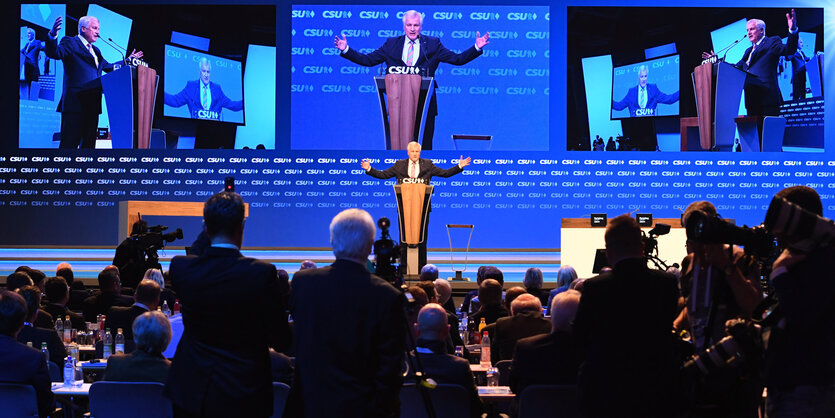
[290,259,406,417]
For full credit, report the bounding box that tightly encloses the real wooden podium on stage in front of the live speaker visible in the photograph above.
[394,183,435,277]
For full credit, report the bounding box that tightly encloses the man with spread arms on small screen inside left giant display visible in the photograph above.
[165,58,244,120]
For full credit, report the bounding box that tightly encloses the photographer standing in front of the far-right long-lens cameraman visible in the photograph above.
[673,201,763,417]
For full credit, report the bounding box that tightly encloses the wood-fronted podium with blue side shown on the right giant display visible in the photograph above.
[691,61,748,150]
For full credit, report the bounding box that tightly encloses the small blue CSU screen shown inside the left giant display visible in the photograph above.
[163,45,244,124]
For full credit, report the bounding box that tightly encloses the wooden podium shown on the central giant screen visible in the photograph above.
[374,74,435,150]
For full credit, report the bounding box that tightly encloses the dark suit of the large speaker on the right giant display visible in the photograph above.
[736,31,799,116]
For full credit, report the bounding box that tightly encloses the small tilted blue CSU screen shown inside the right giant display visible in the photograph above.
[612,55,679,119]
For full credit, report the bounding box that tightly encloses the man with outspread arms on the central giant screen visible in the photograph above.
[333,10,490,150]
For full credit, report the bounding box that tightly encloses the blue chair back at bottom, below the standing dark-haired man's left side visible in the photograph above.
[90,381,173,418]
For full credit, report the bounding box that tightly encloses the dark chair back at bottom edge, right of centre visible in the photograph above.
[519,385,580,418]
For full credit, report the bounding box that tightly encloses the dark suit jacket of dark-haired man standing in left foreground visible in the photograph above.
[165,247,290,417]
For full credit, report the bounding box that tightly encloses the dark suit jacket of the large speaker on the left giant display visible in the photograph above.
[46,36,113,114]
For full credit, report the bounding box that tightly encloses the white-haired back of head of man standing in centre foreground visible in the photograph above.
[330,209,377,260]
